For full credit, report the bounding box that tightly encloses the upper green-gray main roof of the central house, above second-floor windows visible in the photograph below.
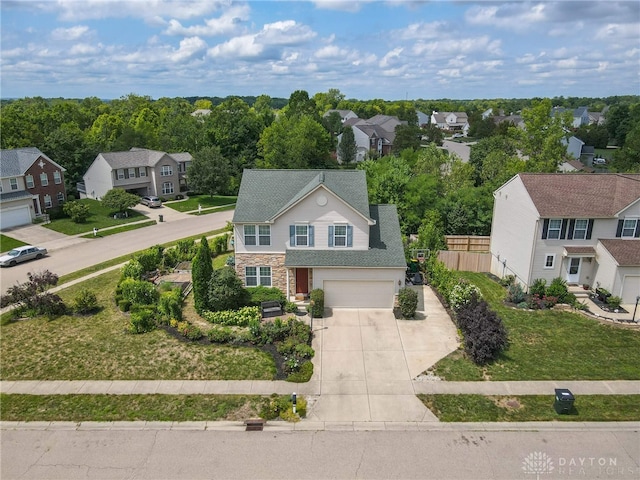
[233,169,371,223]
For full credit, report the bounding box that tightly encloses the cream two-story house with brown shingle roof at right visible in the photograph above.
[491,173,640,304]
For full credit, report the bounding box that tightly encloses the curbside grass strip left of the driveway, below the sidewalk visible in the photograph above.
[0,394,268,422]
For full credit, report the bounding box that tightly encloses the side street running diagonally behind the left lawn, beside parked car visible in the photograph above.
[0,210,233,293]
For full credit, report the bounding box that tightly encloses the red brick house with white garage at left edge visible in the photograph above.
[0,147,66,230]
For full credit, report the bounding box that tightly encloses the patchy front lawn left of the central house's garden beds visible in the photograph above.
[0,270,276,380]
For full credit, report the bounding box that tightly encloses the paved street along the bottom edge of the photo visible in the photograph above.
[0,426,640,480]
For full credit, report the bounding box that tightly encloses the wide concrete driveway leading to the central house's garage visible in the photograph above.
[307,287,458,422]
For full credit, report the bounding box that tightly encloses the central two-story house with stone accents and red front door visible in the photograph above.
[233,170,406,308]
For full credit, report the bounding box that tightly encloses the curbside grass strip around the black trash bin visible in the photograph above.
[418,394,640,422]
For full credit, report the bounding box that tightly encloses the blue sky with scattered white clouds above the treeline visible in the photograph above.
[0,0,640,100]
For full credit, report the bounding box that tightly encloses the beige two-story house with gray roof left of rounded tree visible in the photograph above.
[78,148,192,200]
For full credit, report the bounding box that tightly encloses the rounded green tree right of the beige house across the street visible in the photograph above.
[187,146,231,196]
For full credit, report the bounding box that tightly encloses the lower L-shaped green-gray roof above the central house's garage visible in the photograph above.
[285,205,407,268]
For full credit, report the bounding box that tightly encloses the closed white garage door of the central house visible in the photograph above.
[323,280,394,308]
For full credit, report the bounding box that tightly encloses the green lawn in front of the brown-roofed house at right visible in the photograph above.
[433,272,640,380]
